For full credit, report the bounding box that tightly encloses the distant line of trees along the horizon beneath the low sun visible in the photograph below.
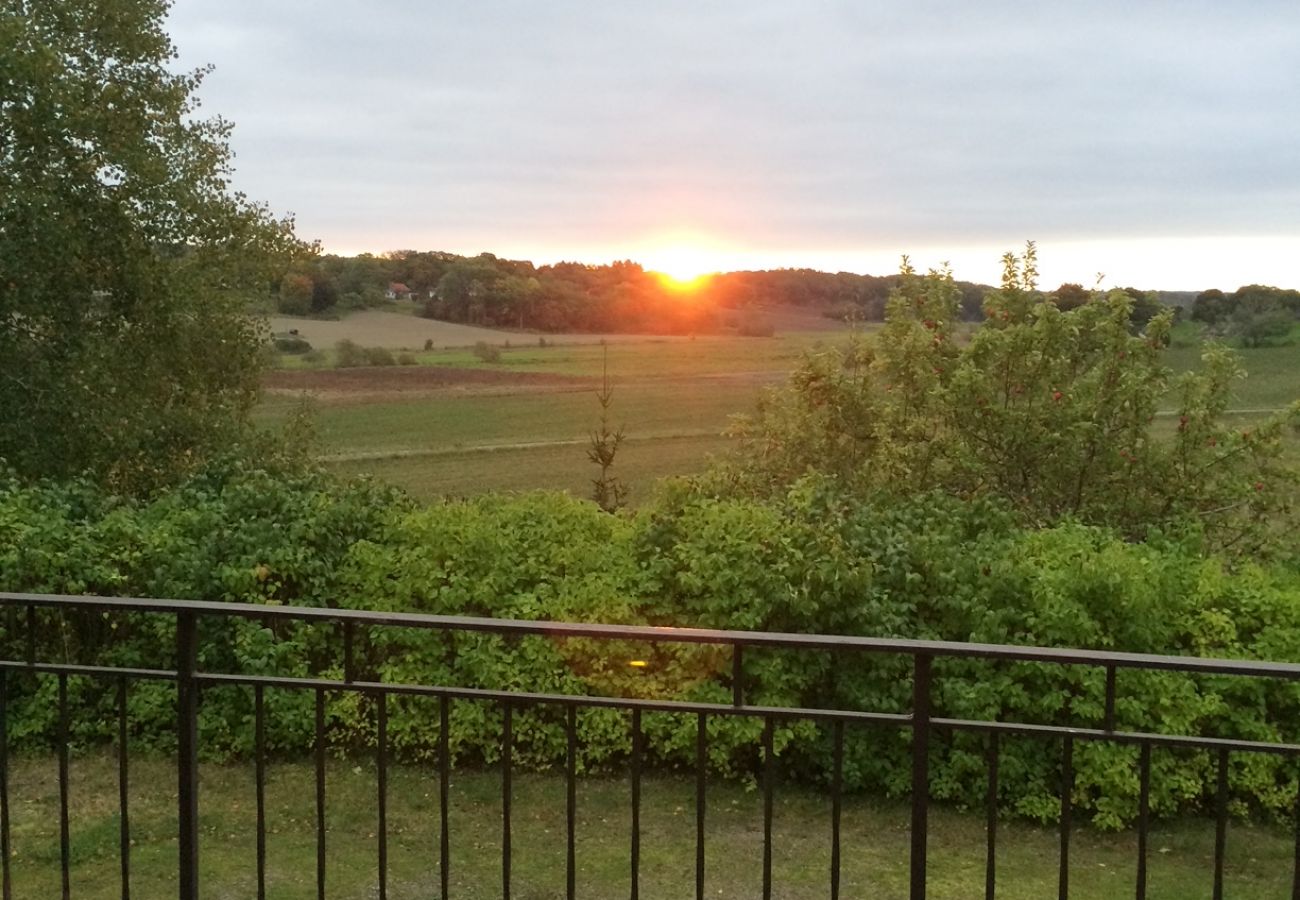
[276,250,1284,334]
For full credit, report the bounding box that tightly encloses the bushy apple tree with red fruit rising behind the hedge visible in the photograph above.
[711,245,1300,555]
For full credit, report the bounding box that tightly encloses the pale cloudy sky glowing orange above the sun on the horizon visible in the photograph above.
[169,0,1300,290]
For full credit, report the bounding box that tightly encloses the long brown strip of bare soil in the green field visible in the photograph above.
[263,365,593,402]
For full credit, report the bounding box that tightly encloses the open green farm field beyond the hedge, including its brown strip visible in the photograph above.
[259,321,1300,502]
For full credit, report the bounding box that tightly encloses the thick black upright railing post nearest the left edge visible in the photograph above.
[176,611,199,900]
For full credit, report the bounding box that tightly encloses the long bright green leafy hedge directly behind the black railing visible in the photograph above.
[0,462,1300,827]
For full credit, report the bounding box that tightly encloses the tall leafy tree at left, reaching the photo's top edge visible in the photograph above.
[0,0,299,489]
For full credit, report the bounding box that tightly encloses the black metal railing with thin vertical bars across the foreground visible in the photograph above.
[0,593,1300,900]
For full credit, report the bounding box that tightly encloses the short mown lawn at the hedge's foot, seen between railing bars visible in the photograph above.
[8,754,1295,900]
